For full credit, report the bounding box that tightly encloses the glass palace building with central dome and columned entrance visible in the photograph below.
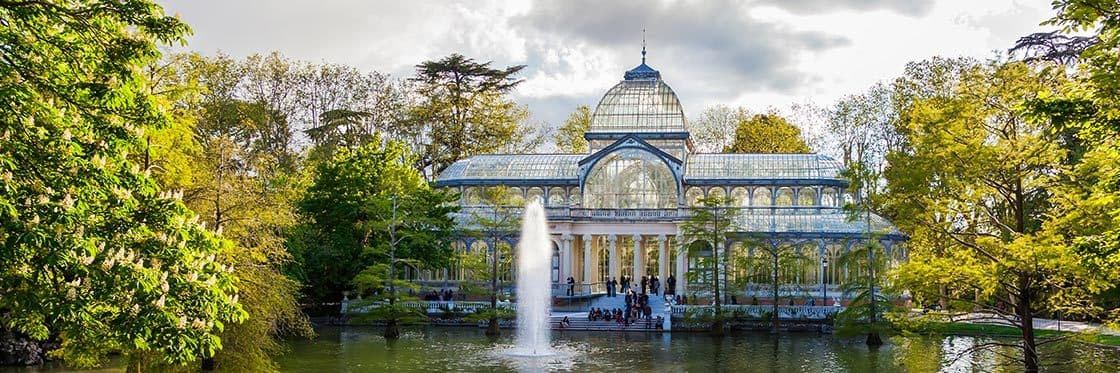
[423,53,906,291]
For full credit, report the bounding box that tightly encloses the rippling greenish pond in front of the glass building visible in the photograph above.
[279,327,1117,372]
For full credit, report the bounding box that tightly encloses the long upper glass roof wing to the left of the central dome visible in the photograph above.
[439,155,587,181]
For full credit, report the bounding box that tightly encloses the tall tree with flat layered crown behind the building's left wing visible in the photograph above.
[411,54,525,179]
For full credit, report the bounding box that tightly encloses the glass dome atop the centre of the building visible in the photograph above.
[587,78,688,133]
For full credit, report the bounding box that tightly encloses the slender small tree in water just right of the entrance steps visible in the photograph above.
[679,196,738,334]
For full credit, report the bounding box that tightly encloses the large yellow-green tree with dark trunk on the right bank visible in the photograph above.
[886,62,1107,371]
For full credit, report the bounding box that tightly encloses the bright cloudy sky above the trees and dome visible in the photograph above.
[164,0,1053,129]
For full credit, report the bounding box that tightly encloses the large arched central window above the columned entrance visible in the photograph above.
[584,149,678,208]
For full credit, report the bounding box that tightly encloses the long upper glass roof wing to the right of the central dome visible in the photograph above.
[684,153,842,180]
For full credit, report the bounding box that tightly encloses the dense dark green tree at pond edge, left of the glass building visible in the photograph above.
[293,139,455,301]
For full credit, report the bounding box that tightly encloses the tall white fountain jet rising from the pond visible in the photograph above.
[514,199,552,355]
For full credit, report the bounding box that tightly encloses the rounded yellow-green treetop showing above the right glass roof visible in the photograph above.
[724,113,811,153]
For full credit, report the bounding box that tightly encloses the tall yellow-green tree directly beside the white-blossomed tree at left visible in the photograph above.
[140,55,312,371]
